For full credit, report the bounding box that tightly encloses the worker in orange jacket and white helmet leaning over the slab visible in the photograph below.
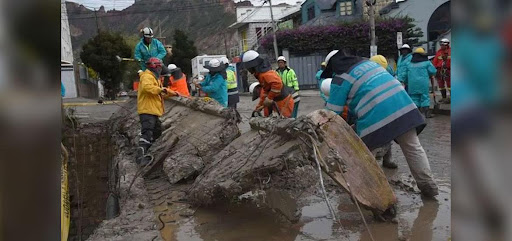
[242,50,294,118]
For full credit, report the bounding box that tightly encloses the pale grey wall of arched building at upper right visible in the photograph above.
[386,0,449,49]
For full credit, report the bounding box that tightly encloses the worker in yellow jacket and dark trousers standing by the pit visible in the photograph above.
[135,57,176,166]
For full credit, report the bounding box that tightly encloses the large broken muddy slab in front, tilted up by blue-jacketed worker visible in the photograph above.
[189,110,396,213]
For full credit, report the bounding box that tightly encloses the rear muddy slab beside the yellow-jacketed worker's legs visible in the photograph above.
[109,97,240,183]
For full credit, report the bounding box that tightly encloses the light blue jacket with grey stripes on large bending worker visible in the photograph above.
[326,60,425,150]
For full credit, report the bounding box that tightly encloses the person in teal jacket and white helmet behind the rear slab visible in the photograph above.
[196,59,228,107]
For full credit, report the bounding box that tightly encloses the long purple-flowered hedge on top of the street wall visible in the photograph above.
[260,17,423,59]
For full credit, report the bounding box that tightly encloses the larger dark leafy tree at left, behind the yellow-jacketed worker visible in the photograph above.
[80,31,132,99]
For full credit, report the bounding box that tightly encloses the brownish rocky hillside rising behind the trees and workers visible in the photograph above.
[66,0,242,57]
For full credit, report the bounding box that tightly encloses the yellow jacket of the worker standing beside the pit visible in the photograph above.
[137,69,164,116]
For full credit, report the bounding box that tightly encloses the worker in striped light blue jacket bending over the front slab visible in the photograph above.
[321,49,438,197]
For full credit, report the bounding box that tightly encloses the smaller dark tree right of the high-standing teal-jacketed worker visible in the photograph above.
[169,29,197,76]
